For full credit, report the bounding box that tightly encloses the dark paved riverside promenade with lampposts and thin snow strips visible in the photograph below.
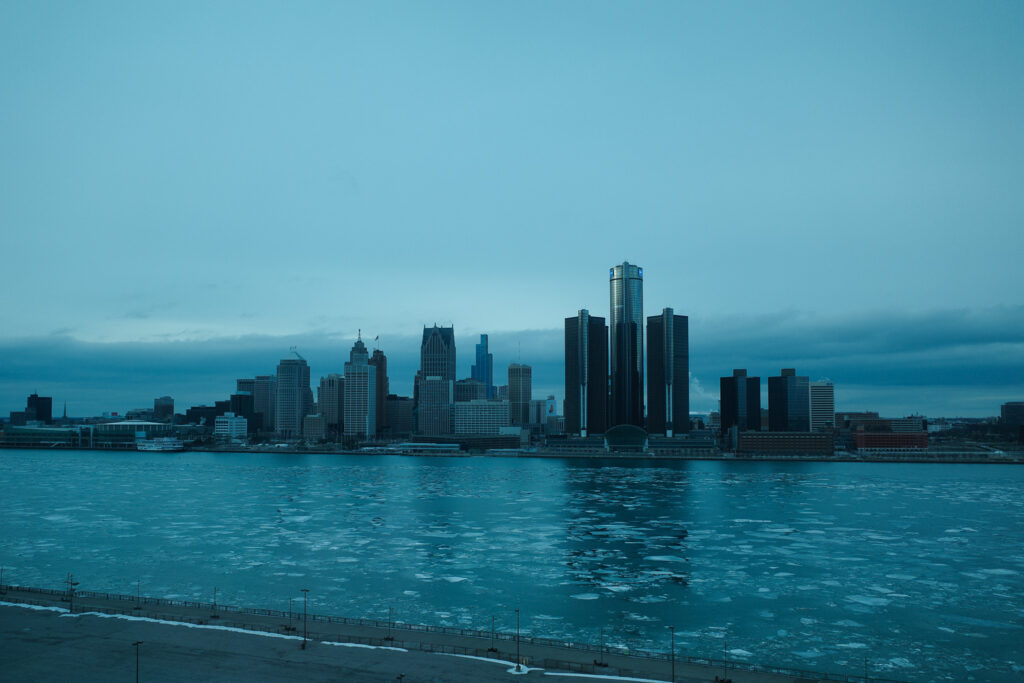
[0,587,901,683]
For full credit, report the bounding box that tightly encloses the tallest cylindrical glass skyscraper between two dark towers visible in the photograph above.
[608,261,644,427]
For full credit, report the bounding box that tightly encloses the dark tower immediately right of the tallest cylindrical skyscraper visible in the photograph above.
[647,308,690,436]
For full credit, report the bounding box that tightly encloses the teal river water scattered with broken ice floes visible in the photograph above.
[0,451,1024,681]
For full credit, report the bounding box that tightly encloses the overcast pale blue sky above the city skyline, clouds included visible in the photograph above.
[0,0,1024,417]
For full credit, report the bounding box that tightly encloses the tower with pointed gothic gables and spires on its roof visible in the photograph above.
[414,324,455,436]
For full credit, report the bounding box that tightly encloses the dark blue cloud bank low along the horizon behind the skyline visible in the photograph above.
[0,306,1024,416]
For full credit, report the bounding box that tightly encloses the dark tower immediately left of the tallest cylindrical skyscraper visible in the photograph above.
[564,308,608,436]
